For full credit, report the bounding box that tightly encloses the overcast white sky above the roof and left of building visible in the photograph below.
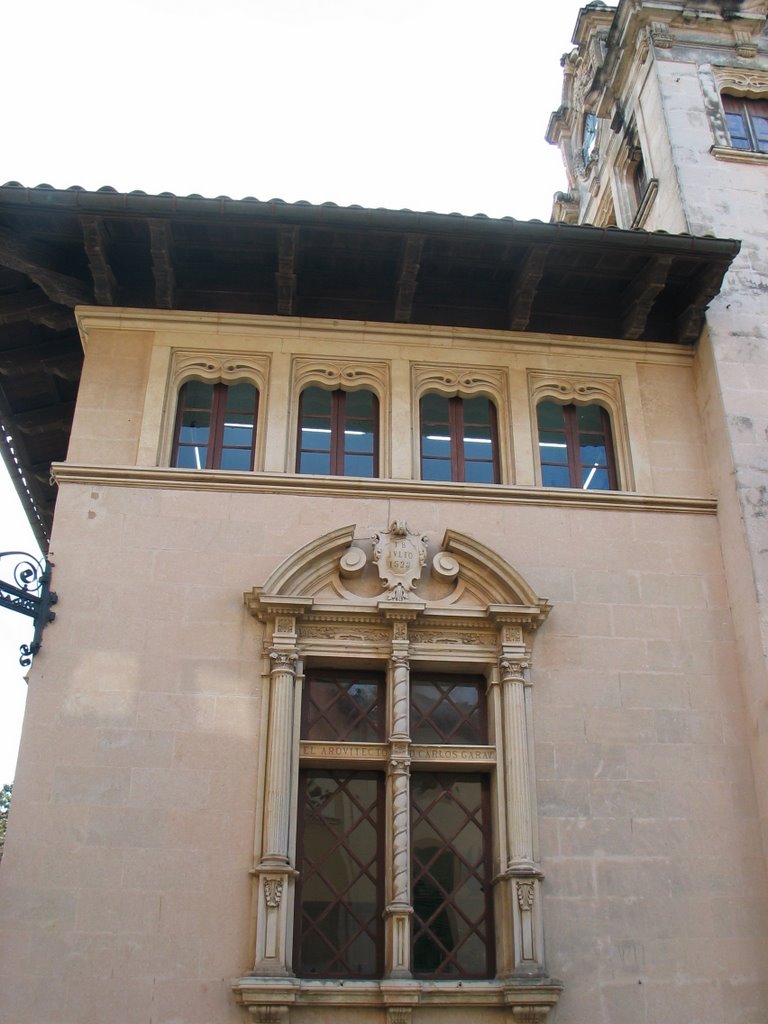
[0,0,582,784]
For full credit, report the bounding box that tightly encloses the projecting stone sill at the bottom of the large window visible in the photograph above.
[232,975,562,1022]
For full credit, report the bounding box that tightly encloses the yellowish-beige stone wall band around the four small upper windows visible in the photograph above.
[70,309,710,496]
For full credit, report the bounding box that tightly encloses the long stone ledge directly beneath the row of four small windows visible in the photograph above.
[51,462,717,515]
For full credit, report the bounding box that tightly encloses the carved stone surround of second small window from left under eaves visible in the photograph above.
[286,356,391,478]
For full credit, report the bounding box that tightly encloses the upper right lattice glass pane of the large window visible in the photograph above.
[411,675,487,744]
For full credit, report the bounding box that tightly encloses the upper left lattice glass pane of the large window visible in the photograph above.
[301,672,385,743]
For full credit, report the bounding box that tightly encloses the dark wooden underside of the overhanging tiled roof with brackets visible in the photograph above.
[0,184,738,541]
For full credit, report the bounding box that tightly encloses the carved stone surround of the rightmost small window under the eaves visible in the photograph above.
[528,370,635,490]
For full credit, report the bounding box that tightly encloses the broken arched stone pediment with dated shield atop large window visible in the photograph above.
[245,521,549,629]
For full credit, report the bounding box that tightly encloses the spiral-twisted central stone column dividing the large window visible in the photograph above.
[386,623,413,978]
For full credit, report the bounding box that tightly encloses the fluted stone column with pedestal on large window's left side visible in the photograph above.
[254,644,298,975]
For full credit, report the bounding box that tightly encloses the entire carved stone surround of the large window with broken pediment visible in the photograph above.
[234,524,561,1022]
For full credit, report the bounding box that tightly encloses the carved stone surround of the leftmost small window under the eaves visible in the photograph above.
[160,349,269,472]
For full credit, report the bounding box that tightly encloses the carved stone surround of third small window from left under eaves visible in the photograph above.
[411,364,514,486]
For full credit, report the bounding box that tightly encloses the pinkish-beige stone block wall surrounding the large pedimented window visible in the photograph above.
[0,466,768,1024]
